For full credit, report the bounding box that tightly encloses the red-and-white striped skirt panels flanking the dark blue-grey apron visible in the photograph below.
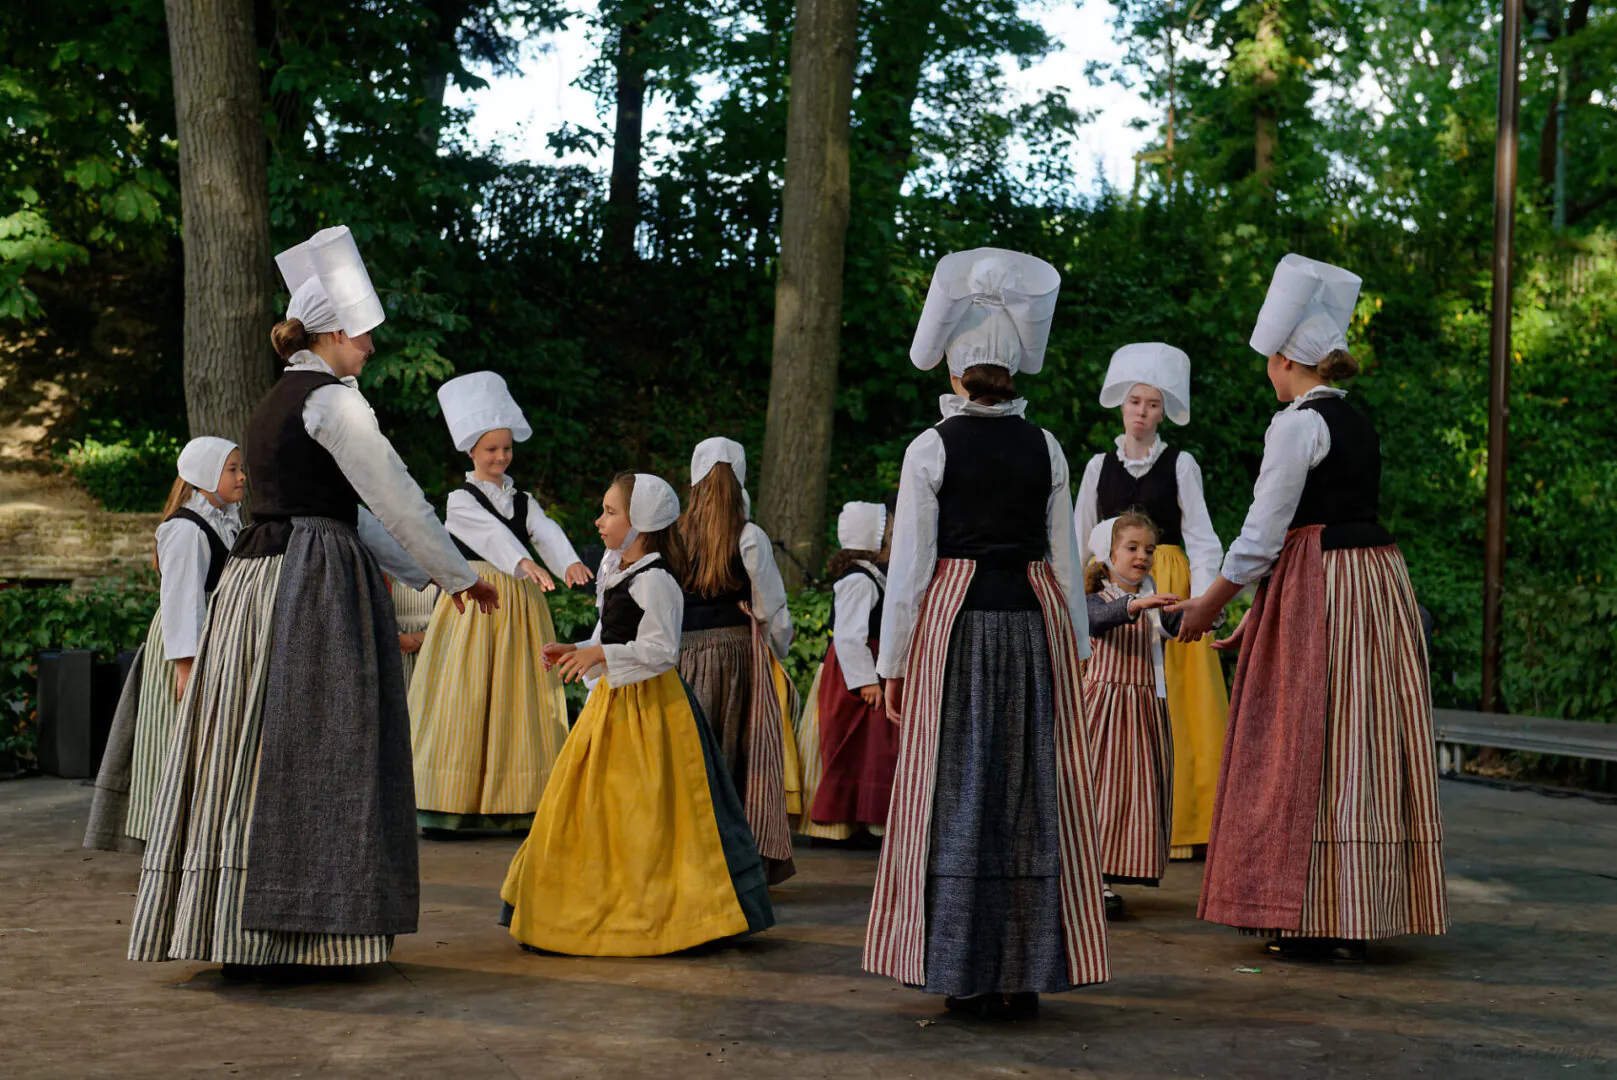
[863,559,1109,986]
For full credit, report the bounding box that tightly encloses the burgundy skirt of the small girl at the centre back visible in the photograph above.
[809,643,899,825]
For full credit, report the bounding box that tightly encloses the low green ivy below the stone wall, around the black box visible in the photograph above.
[0,571,157,773]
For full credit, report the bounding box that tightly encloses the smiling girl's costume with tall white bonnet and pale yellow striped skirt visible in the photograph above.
[409,372,579,833]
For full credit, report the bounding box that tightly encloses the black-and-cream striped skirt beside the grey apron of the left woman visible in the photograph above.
[129,556,393,965]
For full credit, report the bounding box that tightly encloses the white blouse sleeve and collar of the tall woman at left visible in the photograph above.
[288,349,477,592]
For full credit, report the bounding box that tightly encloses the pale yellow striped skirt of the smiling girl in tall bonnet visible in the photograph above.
[409,561,568,828]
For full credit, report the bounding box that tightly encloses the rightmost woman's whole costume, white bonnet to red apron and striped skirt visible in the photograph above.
[1200,255,1449,941]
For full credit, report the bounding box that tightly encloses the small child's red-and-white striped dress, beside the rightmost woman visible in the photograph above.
[1083,582,1174,884]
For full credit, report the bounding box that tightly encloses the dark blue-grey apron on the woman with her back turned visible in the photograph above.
[922,611,1072,996]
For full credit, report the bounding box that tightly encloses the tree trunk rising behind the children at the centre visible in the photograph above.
[758,0,859,587]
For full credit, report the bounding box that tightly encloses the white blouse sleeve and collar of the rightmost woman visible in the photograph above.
[1224,386,1347,585]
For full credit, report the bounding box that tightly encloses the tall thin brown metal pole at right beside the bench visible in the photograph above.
[1483,0,1522,713]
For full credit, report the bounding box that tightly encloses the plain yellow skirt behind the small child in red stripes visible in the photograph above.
[1151,543,1229,859]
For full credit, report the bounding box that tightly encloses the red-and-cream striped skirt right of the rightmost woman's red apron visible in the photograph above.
[1281,545,1449,941]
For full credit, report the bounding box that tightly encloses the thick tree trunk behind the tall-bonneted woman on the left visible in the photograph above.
[167,0,275,443]
